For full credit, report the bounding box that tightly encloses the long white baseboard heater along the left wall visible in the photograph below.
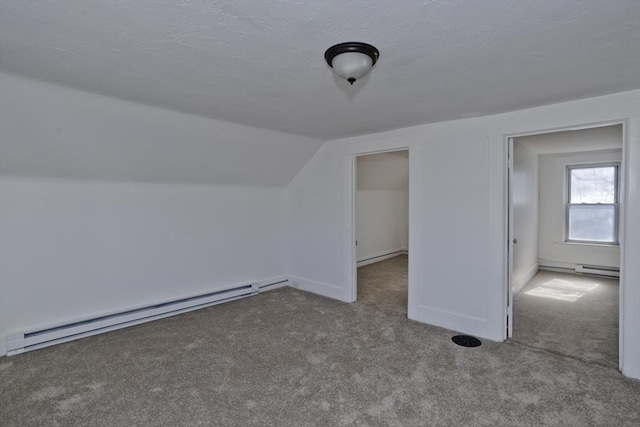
[7,279,288,356]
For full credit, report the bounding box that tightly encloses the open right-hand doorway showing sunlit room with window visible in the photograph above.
[508,125,624,368]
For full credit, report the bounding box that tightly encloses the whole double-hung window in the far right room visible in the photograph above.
[566,163,618,244]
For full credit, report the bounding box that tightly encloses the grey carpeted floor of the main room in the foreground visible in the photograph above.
[0,288,640,426]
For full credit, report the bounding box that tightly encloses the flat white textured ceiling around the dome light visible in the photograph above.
[0,0,640,139]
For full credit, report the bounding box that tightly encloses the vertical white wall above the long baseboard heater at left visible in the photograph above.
[0,177,286,342]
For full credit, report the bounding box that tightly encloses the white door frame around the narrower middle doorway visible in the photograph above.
[344,133,421,319]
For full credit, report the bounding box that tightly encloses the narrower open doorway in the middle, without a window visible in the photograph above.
[355,150,409,317]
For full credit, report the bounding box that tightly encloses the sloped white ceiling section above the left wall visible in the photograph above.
[0,73,323,187]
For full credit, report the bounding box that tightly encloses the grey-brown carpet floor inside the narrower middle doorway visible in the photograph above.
[358,255,409,317]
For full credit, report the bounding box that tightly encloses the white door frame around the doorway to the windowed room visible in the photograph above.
[504,119,630,370]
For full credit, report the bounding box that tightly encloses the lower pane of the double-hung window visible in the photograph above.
[569,205,616,243]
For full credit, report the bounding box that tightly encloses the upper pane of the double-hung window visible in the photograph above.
[569,166,616,203]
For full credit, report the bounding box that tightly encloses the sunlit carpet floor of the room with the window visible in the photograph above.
[513,271,619,368]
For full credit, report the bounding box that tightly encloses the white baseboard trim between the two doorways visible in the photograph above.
[410,305,492,341]
